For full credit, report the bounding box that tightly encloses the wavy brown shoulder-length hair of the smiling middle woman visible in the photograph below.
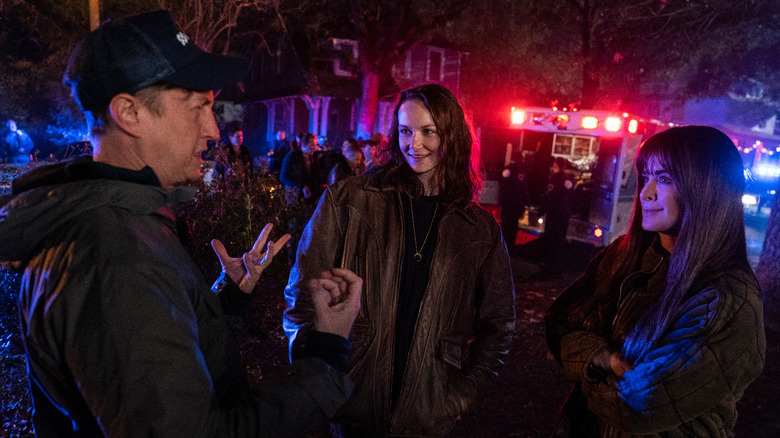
[374,84,482,207]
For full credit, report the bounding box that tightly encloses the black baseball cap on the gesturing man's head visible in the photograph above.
[62,10,249,111]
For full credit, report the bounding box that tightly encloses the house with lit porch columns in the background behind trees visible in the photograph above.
[223,38,467,155]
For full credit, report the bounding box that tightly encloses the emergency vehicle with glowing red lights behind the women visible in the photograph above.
[479,107,672,246]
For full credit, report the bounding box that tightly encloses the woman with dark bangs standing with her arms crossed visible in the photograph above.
[545,126,765,437]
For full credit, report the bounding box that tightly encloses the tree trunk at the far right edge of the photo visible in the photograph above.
[756,177,780,324]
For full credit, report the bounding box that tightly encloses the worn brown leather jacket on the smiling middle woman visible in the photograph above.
[284,175,515,437]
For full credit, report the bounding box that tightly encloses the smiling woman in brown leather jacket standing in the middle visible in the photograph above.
[284,85,515,438]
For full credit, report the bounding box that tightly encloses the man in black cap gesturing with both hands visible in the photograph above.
[0,11,362,437]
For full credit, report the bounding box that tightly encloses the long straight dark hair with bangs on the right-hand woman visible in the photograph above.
[615,126,750,361]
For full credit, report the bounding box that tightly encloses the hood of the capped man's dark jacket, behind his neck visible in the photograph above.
[0,159,197,269]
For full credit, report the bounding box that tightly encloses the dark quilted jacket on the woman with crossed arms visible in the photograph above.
[545,236,766,437]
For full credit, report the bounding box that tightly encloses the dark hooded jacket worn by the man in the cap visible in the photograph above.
[0,160,351,438]
